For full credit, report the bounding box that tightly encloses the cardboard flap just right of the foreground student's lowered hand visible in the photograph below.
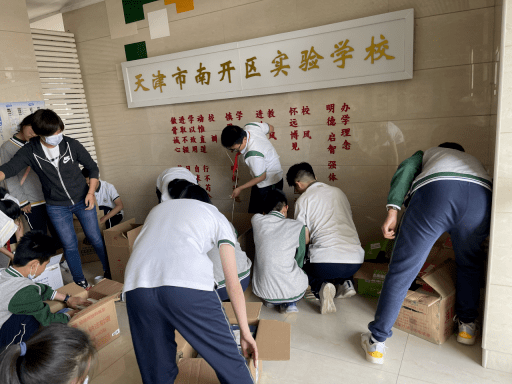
[256,320,291,361]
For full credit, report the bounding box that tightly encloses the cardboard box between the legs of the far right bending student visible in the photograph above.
[394,258,455,344]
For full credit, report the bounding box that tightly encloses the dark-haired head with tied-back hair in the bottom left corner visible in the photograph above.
[0,324,96,384]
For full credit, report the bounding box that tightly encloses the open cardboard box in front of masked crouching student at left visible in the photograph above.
[47,279,123,350]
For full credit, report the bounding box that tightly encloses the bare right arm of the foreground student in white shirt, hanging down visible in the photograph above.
[219,244,258,367]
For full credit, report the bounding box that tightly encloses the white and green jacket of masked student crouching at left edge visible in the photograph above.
[0,267,69,328]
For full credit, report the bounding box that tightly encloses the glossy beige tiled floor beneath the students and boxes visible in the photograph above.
[75,263,512,384]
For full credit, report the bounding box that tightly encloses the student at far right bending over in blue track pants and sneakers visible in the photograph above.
[361,143,492,364]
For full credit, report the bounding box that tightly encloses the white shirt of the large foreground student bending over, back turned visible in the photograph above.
[123,199,236,292]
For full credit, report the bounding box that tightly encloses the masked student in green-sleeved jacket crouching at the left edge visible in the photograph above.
[0,231,91,350]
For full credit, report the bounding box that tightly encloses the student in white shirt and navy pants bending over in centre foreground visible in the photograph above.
[123,180,258,384]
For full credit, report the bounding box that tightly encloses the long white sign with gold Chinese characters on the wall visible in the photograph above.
[122,9,414,108]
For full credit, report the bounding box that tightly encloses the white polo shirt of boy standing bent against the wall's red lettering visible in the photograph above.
[241,123,283,188]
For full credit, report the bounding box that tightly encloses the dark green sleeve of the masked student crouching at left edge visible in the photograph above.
[7,285,69,327]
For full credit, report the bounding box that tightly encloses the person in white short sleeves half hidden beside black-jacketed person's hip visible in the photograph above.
[82,168,124,229]
